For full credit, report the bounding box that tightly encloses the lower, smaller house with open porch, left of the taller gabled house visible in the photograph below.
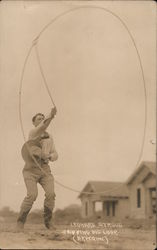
[79,181,129,218]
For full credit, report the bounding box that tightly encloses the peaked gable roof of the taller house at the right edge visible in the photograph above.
[126,161,156,184]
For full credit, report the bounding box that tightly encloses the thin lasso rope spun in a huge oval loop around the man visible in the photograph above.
[19,6,147,194]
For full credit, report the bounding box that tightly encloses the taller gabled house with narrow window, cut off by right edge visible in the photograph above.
[126,162,156,218]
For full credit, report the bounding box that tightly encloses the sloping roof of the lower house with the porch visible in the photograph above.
[79,181,128,198]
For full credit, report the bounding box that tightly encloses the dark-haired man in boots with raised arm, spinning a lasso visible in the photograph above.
[17,108,58,230]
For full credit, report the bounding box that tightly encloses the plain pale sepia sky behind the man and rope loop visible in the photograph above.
[0,1,156,211]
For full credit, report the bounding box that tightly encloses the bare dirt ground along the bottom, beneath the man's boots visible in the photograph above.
[0,222,155,250]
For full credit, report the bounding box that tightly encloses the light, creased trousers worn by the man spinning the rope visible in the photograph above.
[21,168,55,212]
